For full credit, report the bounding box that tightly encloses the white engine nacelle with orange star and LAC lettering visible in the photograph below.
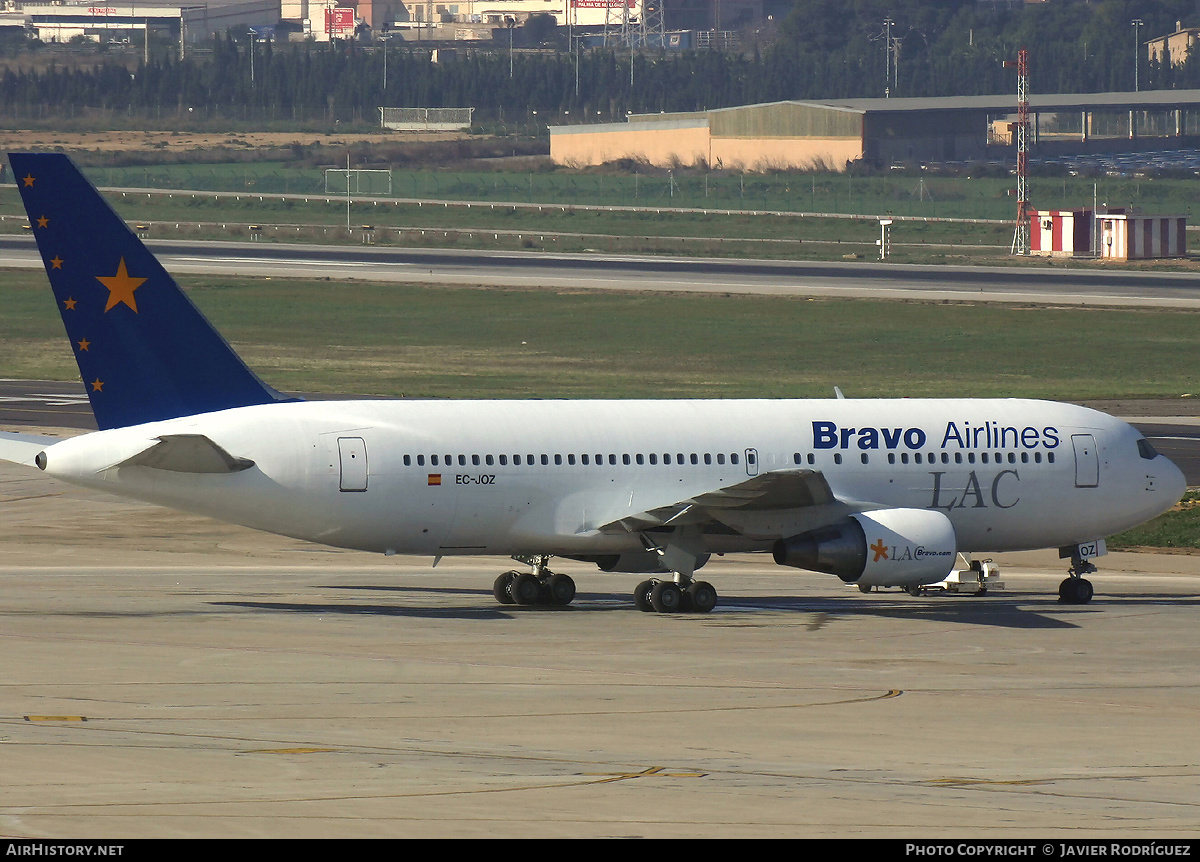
[772,509,958,587]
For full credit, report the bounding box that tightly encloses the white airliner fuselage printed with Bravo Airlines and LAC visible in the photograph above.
[39,400,1184,556]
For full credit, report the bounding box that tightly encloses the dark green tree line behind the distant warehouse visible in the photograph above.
[0,0,1200,124]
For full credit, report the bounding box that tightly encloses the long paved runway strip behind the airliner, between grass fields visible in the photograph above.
[0,237,1200,309]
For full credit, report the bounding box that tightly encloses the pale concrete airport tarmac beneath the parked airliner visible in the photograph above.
[0,456,1200,839]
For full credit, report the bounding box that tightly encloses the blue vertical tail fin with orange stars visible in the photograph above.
[8,152,294,429]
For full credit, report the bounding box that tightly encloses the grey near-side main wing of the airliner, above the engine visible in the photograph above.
[600,469,835,533]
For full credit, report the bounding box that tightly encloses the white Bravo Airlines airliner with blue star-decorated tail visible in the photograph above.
[0,154,1186,613]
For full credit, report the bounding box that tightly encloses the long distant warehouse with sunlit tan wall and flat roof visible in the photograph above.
[550,90,1200,170]
